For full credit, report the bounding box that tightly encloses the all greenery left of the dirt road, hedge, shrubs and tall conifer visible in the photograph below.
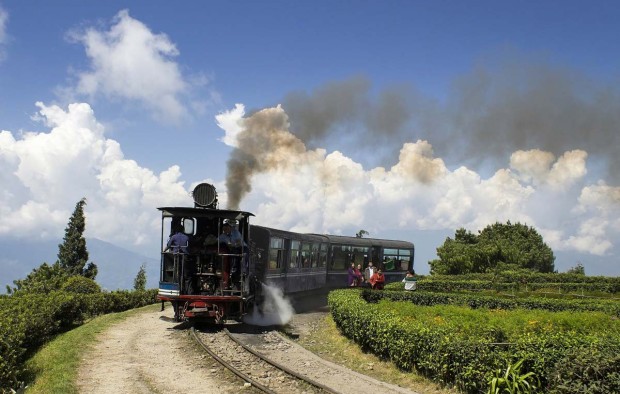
[0,199,157,393]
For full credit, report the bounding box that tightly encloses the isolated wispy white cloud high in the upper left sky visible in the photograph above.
[69,10,207,121]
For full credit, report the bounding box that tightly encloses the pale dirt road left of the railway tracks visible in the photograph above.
[78,307,244,394]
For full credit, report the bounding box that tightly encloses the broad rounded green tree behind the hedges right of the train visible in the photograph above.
[429,222,555,275]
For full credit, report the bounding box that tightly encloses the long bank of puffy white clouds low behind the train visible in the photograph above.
[0,103,620,264]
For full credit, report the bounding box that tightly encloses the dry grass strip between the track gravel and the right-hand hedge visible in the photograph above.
[297,316,458,394]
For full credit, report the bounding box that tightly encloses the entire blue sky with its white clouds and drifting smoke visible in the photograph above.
[0,0,620,275]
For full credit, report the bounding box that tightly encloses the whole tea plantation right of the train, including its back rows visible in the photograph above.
[329,274,620,393]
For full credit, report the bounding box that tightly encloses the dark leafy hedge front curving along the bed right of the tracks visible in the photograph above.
[328,289,620,393]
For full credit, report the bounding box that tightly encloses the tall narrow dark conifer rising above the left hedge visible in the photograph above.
[58,198,97,279]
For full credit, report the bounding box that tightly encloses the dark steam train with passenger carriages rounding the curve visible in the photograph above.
[157,183,415,324]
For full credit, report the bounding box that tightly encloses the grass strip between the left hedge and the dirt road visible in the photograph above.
[26,304,161,394]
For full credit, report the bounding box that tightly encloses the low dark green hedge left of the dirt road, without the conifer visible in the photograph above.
[0,283,157,392]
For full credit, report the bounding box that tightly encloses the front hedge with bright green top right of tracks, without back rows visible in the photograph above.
[329,284,620,394]
